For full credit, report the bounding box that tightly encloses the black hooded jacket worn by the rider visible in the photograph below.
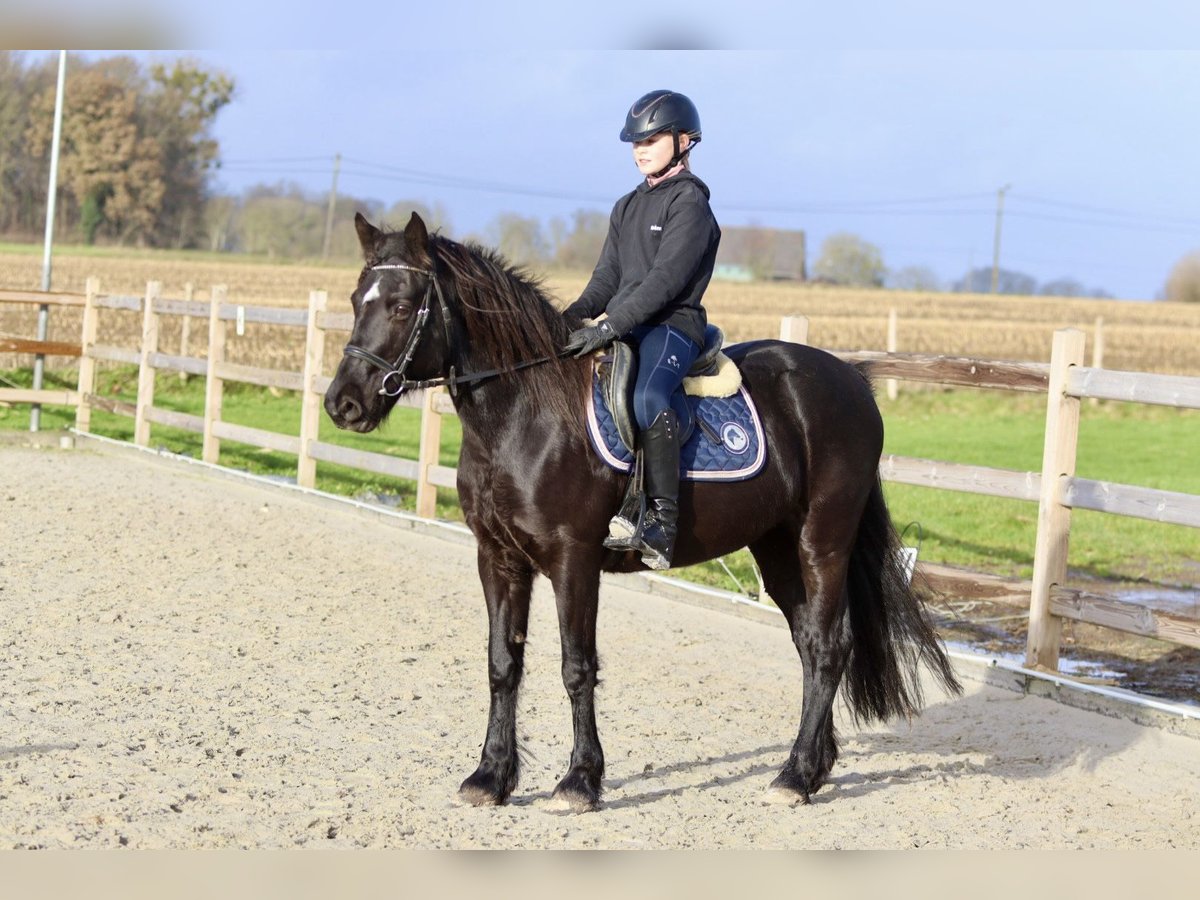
[566,169,721,346]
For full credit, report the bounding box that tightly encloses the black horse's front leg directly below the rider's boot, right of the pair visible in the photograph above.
[551,545,604,812]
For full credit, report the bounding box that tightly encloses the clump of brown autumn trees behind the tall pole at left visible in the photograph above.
[0,52,233,246]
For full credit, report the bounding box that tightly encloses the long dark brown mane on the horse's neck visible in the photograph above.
[430,235,582,419]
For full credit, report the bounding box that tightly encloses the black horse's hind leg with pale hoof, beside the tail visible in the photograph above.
[751,532,851,803]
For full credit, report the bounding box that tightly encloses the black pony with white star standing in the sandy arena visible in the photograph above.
[325,214,960,810]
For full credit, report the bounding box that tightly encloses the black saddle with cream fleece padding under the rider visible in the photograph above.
[596,325,742,450]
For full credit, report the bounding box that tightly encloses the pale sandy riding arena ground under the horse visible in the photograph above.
[0,444,1200,848]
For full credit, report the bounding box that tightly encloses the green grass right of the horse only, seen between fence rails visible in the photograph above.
[881,390,1200,583]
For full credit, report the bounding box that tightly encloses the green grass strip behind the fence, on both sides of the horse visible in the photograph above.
[0,368,1200,590]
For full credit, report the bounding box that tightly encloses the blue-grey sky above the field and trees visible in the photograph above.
[16,0,1200,299]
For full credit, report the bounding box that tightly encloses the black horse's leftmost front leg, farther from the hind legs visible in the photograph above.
[458,541,533,806]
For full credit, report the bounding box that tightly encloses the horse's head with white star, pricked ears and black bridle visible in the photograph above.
[325,212,449,432]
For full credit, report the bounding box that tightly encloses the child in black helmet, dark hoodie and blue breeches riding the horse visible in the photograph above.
[566,90,721,569]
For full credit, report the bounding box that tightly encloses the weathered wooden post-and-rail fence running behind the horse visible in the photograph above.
[7,280,1200,670]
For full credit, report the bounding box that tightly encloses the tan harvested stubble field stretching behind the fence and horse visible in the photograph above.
[0,254,1200,374]
